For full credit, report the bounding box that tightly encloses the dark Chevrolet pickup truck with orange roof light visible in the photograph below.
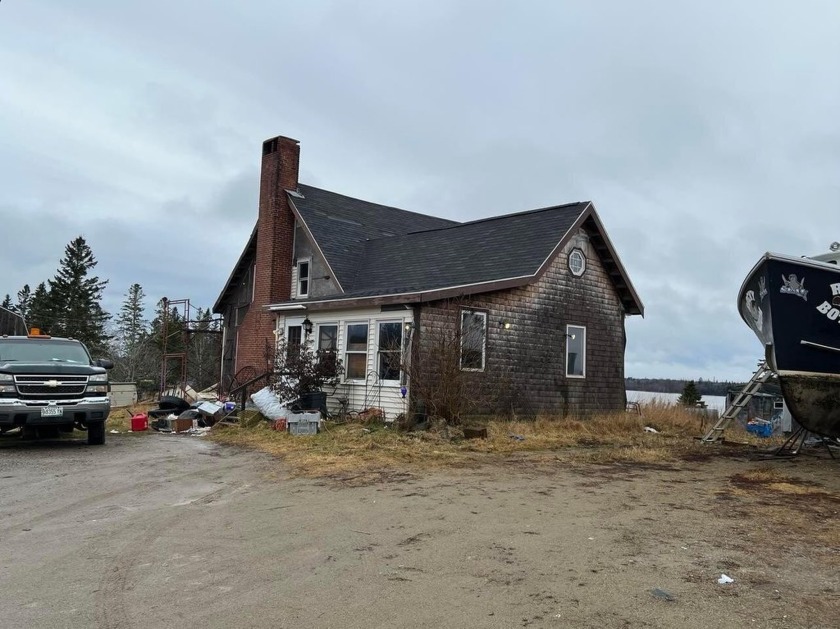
[0,331,114,445]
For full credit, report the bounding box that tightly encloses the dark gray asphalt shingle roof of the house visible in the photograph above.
[291,185,588,296]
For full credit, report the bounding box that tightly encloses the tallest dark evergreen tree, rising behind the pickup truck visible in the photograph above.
[49,236,109,352]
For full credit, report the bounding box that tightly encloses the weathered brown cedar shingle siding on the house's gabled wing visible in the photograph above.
[419,228,625,415]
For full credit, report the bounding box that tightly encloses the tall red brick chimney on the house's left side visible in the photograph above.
[235,136,300,373]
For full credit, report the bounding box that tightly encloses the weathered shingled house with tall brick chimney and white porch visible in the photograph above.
[213,136,643,420]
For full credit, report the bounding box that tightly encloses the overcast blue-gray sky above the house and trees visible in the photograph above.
[0,0,840,381]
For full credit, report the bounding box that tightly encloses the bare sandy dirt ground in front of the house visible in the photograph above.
[0,433,840,628]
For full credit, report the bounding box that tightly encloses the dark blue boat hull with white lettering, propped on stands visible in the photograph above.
[738,253,840,437]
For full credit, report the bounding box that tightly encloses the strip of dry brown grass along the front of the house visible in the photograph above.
[211,403,767,478]
